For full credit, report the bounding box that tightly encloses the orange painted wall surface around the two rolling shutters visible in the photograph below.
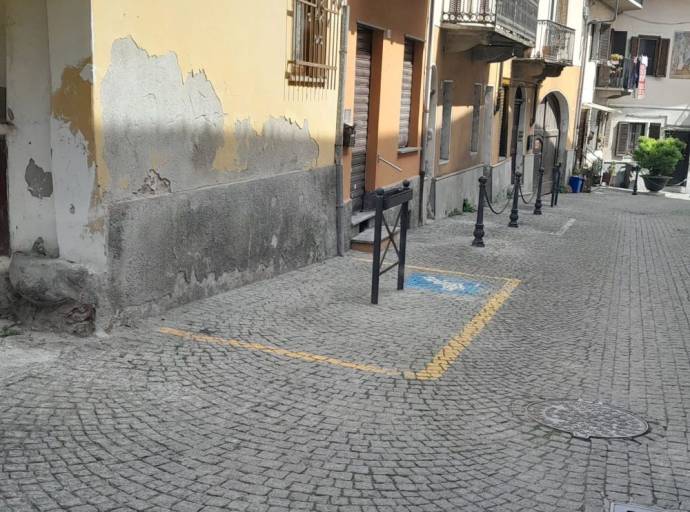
[343,0,428,196]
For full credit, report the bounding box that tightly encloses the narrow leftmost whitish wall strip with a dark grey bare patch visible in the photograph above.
[6,0,58,255]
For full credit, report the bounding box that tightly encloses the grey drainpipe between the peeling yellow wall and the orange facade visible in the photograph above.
[334,1,350,256]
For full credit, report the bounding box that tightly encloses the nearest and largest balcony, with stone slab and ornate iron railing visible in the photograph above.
[441,0,539,55]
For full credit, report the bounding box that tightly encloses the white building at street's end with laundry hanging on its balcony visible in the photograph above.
[581,0,690,190]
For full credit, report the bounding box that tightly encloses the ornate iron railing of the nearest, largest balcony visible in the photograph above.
[443,0,539,47]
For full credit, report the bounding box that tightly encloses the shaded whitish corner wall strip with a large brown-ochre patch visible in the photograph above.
[47,0,106,273]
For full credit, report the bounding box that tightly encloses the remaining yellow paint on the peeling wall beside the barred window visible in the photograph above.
[92,0,339,196]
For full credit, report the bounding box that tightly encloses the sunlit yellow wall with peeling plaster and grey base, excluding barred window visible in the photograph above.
[91,0,337,316]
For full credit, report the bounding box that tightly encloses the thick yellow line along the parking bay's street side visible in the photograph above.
[415,279,520,380]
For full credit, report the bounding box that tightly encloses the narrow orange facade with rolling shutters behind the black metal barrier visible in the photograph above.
[342,0,429,251]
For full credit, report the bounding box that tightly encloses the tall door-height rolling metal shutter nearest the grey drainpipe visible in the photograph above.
[350,26,371,211]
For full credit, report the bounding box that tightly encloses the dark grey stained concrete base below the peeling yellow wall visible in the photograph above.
[108,167,336,317]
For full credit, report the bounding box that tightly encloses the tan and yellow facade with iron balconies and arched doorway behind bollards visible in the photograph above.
[425,0,584,218]
